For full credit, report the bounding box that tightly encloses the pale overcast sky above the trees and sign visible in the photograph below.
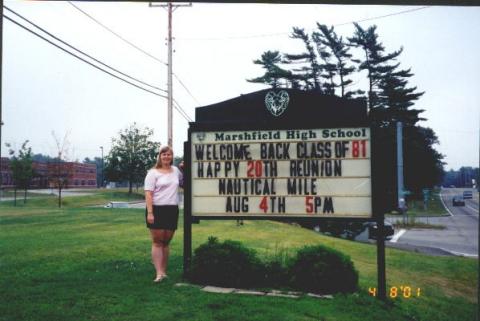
[2,1,480,170]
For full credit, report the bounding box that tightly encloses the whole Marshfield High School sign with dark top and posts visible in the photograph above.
[184,89,386,298]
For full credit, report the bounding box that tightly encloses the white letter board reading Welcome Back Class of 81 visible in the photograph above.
[190,127,372,218]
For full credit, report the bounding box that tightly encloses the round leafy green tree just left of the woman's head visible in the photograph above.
[105,123,160,194]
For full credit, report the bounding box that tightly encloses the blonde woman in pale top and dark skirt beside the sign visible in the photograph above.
[145,146,183,282]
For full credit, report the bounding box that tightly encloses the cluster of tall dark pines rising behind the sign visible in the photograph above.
[247,23,444,206]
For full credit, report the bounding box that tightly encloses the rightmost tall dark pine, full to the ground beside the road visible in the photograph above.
[349,24,444,199]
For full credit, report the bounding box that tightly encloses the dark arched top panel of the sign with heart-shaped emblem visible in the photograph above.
[195,89,368,128]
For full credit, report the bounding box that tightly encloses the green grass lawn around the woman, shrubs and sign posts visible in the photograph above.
[0,192,478,321]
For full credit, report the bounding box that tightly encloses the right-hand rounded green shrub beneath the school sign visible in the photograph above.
[289,245,358,294]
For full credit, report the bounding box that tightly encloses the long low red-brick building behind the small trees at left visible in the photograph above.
[1,157,97,188]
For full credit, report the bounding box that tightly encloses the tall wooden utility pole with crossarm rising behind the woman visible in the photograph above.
[149,2,192,147]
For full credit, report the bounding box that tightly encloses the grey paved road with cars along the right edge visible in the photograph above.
[393,188,478,257]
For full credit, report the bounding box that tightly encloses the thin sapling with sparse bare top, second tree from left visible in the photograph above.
[48,131,72,208]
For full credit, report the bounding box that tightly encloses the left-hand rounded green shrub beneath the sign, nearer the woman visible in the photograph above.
[189,237,264,287]
